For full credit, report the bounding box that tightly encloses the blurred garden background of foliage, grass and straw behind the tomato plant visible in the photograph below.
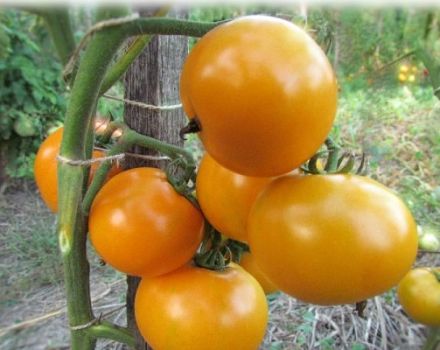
[0,5,440,350]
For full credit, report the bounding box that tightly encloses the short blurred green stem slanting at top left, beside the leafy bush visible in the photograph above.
[39,8,76,64]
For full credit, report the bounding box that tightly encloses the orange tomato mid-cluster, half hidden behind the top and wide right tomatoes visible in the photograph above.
[196,153,272,242]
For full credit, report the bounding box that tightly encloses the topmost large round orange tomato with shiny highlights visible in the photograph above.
[180,16,337,176]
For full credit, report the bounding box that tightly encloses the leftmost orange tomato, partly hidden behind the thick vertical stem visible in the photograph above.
[34,128,122,213]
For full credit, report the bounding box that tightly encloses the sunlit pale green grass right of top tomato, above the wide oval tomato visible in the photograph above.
[332,82,440,231]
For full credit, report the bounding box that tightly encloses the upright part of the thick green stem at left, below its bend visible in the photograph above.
[58,21,125,350]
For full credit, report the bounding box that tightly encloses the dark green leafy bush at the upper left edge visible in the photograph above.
[0,10,66,177]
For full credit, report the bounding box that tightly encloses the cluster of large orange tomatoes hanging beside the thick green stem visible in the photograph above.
[36,16,417,350]
